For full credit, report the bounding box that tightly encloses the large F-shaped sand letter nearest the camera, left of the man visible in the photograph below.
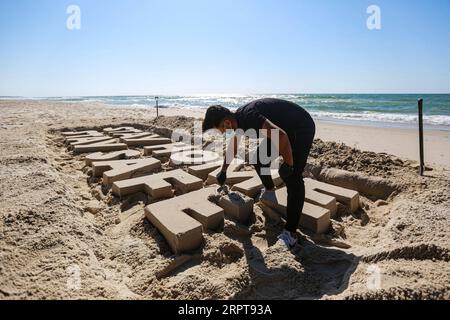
[145,186,224,254]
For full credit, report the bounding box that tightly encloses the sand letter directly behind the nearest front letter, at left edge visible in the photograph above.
[112,169,203,199]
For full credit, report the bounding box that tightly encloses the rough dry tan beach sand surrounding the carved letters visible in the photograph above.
[0,101,450,299]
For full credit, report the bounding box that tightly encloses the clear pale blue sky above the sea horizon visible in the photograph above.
[0,0,450,97]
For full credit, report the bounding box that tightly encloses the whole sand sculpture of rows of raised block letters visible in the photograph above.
[63,127,360,253]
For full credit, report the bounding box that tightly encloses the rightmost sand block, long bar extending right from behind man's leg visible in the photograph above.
[305,178,359,214]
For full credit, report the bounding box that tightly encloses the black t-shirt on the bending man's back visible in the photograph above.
[236,98,315,134]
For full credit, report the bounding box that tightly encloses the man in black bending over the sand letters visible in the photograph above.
[203,99,316,249]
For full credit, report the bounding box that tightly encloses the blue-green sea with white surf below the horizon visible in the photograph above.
[0,94,450,130]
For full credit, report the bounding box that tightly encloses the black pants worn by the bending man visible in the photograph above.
[255,124,316,232]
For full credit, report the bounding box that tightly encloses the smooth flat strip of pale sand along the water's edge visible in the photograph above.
[0,100,450,170]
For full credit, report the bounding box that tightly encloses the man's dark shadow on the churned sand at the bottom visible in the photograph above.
[227,219,359,300]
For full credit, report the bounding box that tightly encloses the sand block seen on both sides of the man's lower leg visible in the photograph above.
[262,188,331,233]
